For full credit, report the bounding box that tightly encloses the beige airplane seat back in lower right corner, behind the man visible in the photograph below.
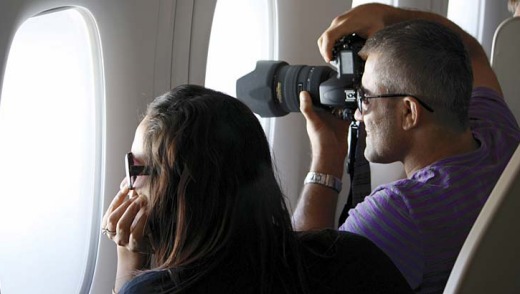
[444,145,520,294]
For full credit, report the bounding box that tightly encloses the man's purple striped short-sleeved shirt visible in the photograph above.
[340,88,520,293]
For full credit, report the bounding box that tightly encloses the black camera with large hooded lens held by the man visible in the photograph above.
[237,33,365,120]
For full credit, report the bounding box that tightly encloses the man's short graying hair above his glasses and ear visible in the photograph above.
[360,20,473,130]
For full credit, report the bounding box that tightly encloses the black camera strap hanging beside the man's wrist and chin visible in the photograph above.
[338,121,372,225]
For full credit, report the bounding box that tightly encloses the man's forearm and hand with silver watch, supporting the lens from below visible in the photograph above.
[293,92,349,231]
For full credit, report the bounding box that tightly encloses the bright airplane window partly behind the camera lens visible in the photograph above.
[206,0,275,96]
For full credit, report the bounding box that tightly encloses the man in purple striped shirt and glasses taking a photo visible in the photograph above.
[293,4,520,293]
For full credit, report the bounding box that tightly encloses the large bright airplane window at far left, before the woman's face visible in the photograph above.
[0,9,103,294]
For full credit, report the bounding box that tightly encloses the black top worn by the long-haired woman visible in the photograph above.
[119,230,413,294]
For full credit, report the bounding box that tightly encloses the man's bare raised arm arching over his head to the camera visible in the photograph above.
[318,4,502,95]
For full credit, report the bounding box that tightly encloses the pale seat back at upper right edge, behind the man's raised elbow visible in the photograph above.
[491,17,520,122]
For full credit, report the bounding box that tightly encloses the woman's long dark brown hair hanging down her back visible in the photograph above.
[140,85,306,293]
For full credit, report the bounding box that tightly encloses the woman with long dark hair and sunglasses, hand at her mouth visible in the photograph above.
[102,85,409,293]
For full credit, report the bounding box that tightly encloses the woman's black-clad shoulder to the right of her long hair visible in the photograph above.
[298,229,412,293]
